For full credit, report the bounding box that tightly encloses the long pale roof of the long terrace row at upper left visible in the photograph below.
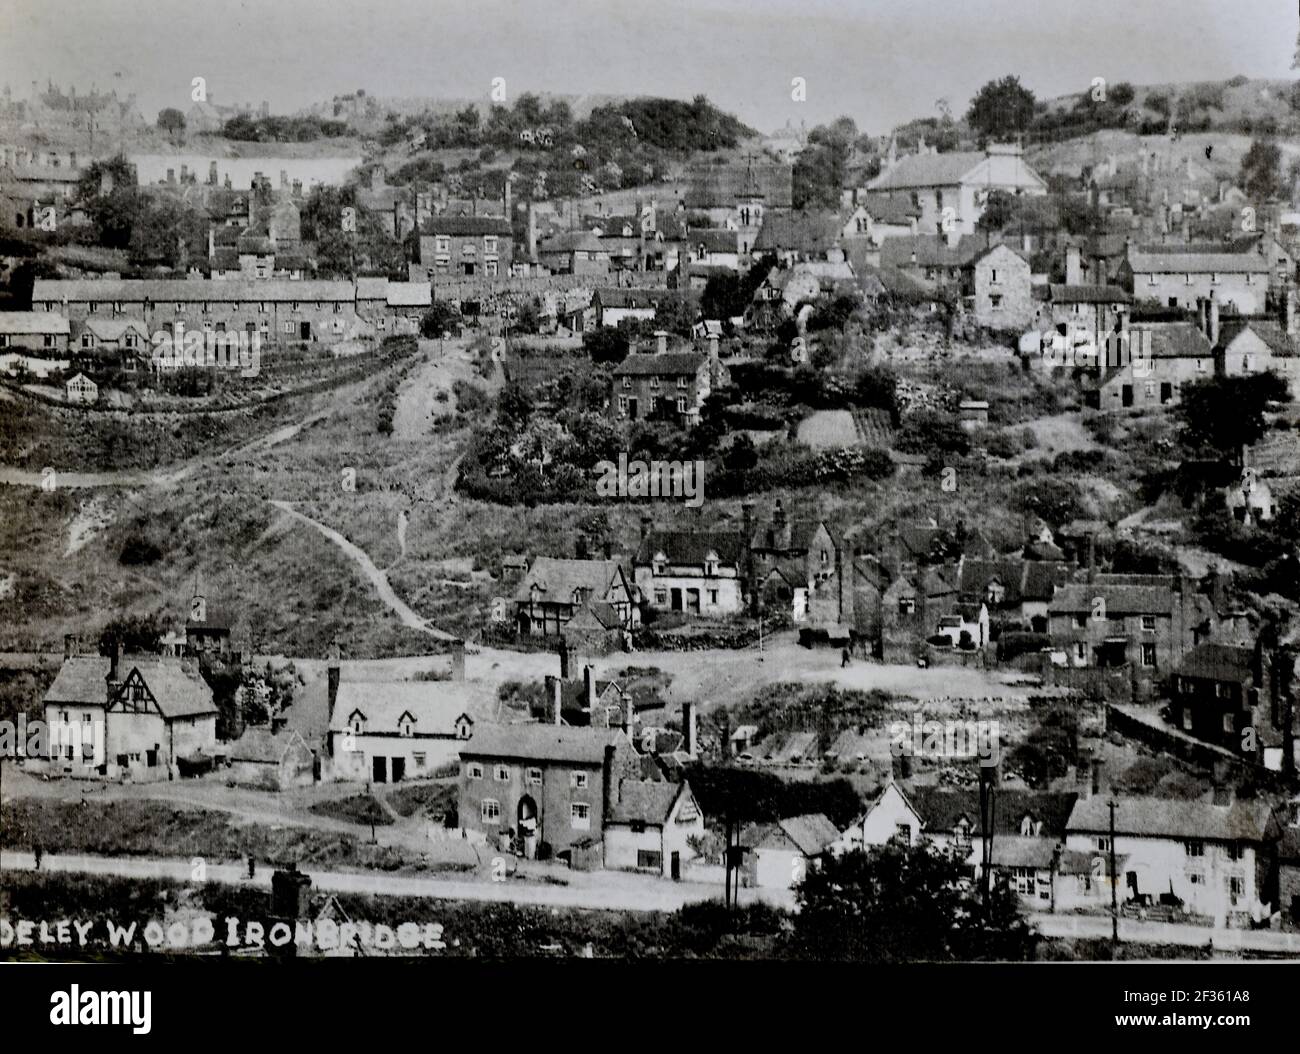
[31,278,356,304]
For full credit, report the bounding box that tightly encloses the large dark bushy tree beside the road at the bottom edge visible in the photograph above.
[790,842,1037,963]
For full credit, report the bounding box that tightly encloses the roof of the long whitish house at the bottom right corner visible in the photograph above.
[1066,795,1277,842]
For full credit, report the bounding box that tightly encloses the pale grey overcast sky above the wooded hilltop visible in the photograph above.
[0,0,1297,133]
